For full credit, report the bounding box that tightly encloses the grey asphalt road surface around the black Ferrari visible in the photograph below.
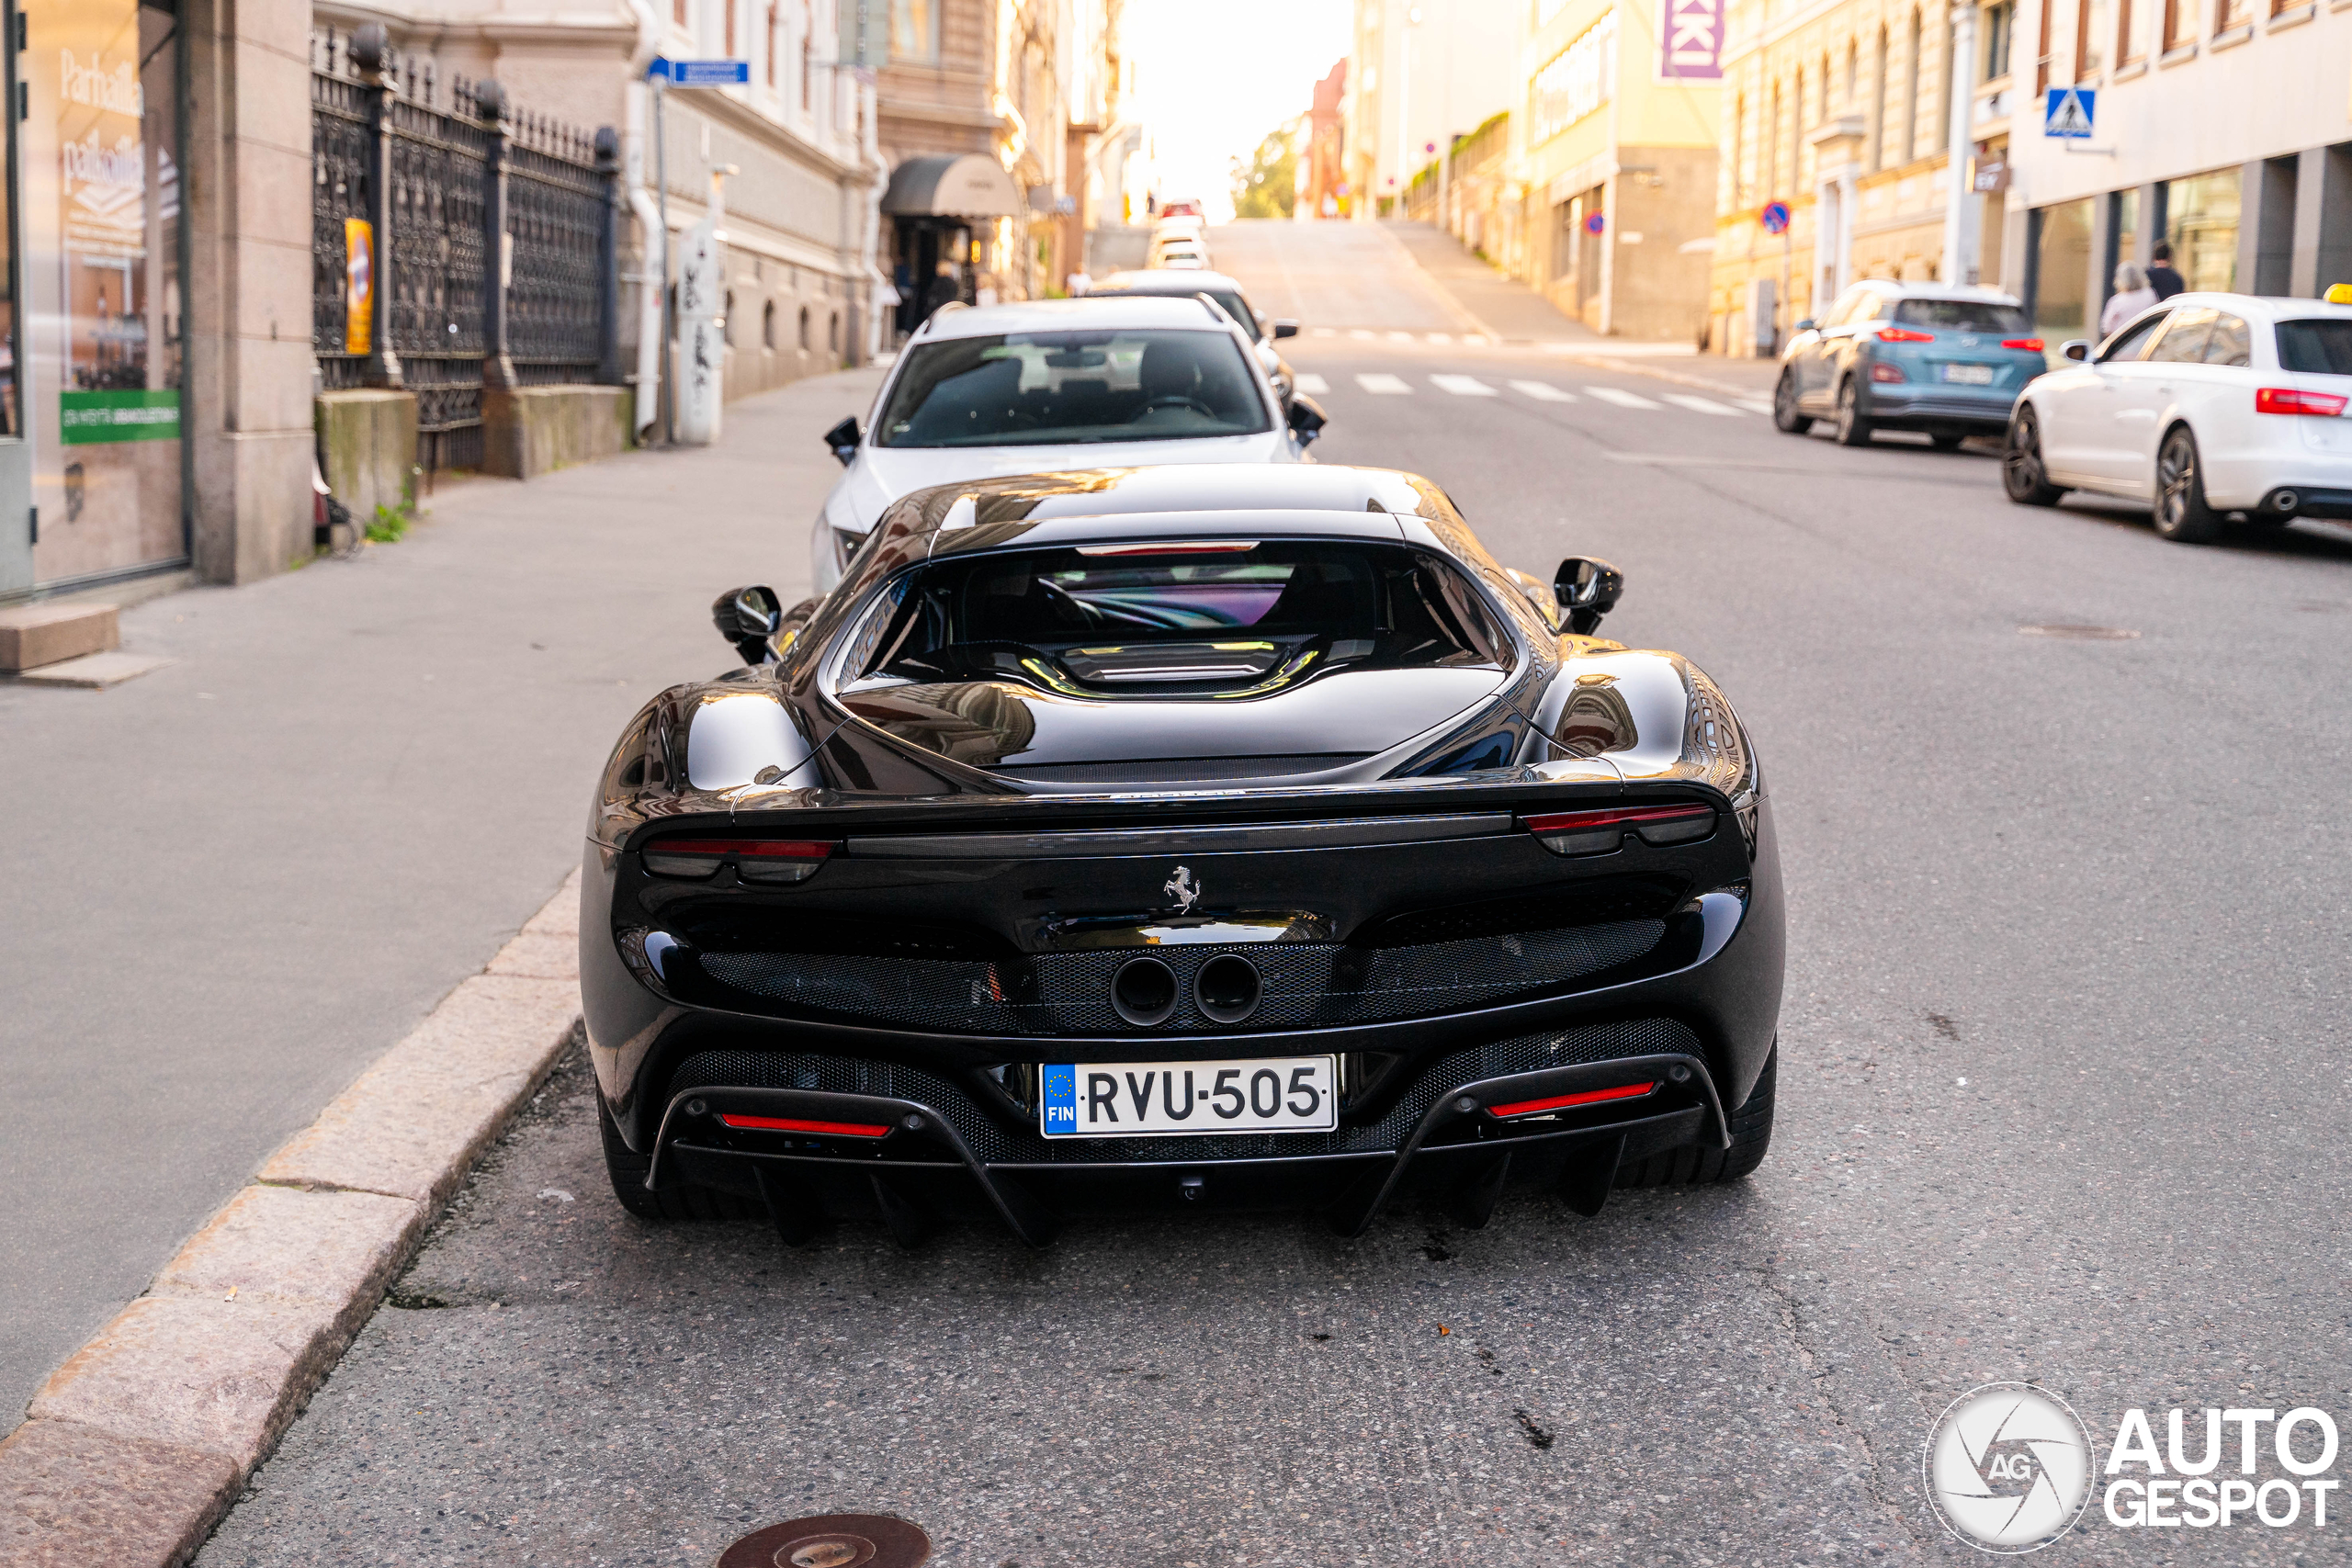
[200,226,2352,1568]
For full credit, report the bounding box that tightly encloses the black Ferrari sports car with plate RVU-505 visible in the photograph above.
[581,466,1782,1244]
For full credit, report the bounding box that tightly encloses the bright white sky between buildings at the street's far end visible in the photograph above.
[1120,0,1352,223]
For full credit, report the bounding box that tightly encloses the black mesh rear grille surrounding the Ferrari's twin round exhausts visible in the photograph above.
[701,919,1665,1034]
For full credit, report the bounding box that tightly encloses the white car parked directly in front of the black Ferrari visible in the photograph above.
[809,294,1324,592]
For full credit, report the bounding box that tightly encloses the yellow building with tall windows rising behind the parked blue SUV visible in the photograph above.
[1708,0,2016,357]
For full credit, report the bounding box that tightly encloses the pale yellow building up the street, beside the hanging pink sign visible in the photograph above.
[1512,0,1724,341]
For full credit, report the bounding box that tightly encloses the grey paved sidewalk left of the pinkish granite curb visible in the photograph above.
[0,371,877,1434]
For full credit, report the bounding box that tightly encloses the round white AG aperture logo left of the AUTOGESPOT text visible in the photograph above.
[1919,1382,2091,1554]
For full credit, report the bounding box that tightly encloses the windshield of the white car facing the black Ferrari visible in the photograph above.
[877,327,1272,446]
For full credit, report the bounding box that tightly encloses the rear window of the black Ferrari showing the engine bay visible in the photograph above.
[840,541,1512,689]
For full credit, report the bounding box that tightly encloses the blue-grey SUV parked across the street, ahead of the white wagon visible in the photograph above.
[1771,280,2049,451]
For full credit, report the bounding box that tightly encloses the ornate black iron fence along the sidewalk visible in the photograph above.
[311,24,618,468]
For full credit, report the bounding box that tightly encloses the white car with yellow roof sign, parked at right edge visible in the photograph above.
[2004,294,2352,543]
